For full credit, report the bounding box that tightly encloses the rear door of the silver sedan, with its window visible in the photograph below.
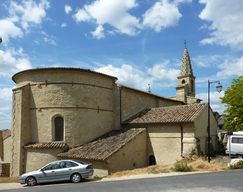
[56,161,73,181]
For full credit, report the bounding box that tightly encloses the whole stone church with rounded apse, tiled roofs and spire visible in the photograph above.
[0,48,217,176]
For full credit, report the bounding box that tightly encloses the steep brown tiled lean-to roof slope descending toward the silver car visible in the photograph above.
[57,128,146,160]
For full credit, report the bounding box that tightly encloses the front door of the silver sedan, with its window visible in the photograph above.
[37,162,59,182]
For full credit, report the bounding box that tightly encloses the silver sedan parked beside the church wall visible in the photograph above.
[19,160,94,186]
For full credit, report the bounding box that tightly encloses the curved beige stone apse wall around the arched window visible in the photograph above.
[13,68,116,146]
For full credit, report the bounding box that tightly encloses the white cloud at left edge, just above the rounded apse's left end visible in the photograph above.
[0,48,32,77]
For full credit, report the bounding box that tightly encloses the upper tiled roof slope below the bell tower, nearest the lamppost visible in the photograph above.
[123,103,207,124]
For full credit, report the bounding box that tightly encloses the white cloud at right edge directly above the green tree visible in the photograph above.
[217,56,243,78]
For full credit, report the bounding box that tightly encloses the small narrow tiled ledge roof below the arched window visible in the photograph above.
[24,141,67,149]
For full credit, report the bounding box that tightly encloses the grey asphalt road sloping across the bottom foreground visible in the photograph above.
[1,170,243,192]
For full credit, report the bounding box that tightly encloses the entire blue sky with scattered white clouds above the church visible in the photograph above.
[0,0,243,129]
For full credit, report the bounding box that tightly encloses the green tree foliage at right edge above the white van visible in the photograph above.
[220,76,243,131]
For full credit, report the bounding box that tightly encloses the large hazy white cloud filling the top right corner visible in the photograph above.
[199,0,243,50]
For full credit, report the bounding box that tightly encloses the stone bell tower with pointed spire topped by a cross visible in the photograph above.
[176,40,196,103]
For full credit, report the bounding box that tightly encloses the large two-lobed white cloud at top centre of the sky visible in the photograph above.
[72,0,192,36]
